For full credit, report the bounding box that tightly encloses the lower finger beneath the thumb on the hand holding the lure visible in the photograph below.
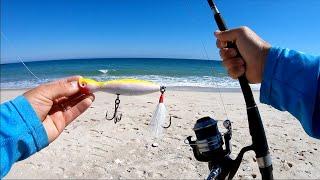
[64,94,95,126]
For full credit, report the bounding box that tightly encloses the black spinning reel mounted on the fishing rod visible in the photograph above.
[186,117,253,179]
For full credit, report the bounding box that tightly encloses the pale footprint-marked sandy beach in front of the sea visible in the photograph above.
[1,89,320,179]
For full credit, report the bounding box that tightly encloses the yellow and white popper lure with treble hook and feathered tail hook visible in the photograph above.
[78,78,171,136]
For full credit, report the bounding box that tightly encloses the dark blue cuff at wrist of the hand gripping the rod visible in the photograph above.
[260,47,282,104]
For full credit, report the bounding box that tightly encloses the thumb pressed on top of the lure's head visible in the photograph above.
[41,76,80,100]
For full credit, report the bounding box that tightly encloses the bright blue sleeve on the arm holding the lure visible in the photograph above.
[0,96,49,178]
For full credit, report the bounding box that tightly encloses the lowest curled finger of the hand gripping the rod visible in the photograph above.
[223,58,245,79]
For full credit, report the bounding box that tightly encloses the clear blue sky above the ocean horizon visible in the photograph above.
[1,0,320,63]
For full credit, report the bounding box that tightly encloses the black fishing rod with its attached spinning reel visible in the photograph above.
[187,0,273,180]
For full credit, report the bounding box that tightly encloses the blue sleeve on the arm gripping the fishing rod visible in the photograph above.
[260,47,320,139]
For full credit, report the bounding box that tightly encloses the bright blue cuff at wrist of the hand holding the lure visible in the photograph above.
[11,96,49,151]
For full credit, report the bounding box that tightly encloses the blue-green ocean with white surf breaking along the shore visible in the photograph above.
[1,58,260,89]
